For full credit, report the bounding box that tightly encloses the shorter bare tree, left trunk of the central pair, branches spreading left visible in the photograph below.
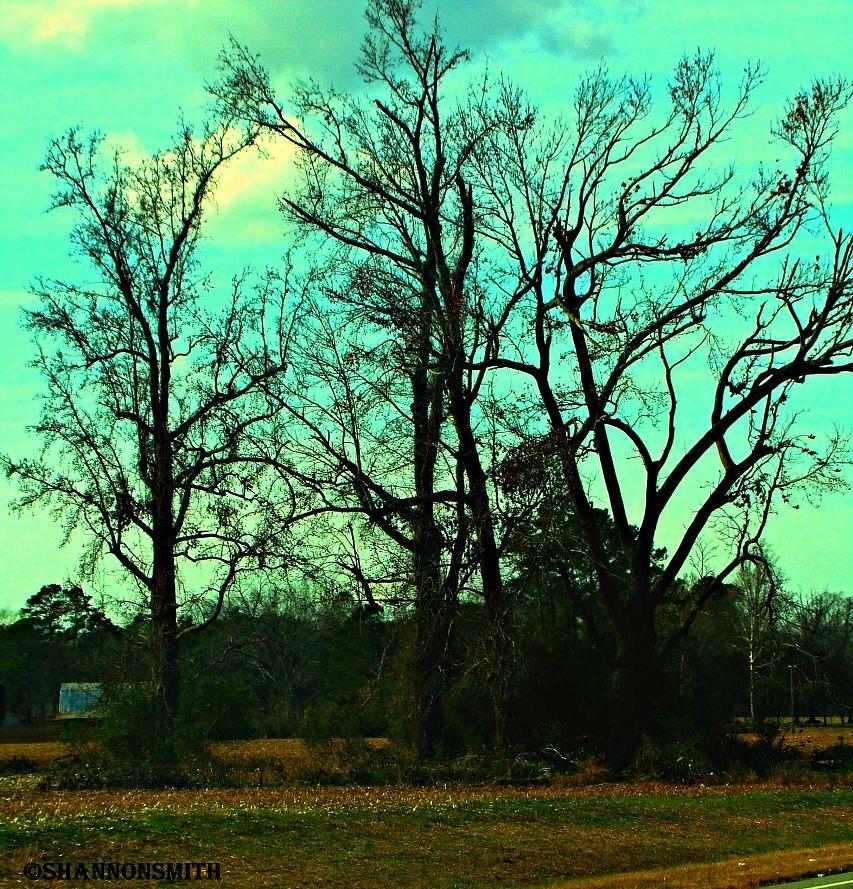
[282,292,470,754]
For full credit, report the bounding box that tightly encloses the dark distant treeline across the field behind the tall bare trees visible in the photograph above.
[0,561,853,754]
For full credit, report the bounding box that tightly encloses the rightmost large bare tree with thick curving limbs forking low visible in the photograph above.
[474,60,853,766]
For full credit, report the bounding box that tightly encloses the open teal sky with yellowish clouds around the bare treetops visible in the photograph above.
[0,0,853,608]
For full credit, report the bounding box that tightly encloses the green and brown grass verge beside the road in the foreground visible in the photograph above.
[0,779,853,889]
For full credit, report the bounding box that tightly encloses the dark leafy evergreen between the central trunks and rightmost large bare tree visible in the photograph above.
[500,462,617,750]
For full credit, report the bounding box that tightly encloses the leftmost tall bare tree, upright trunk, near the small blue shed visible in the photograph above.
[3,121,295,744]
